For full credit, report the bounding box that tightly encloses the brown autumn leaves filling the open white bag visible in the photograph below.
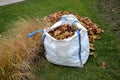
[49,24,77,40]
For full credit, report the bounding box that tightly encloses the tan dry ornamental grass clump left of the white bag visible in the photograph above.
[0,18,48,80]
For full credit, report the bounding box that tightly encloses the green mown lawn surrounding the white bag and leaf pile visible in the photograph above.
[0,0,120,80]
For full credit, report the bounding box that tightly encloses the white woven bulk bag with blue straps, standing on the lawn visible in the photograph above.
[43,14,89,67]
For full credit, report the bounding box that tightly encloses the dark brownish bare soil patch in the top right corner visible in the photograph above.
[101,0,120,39]
